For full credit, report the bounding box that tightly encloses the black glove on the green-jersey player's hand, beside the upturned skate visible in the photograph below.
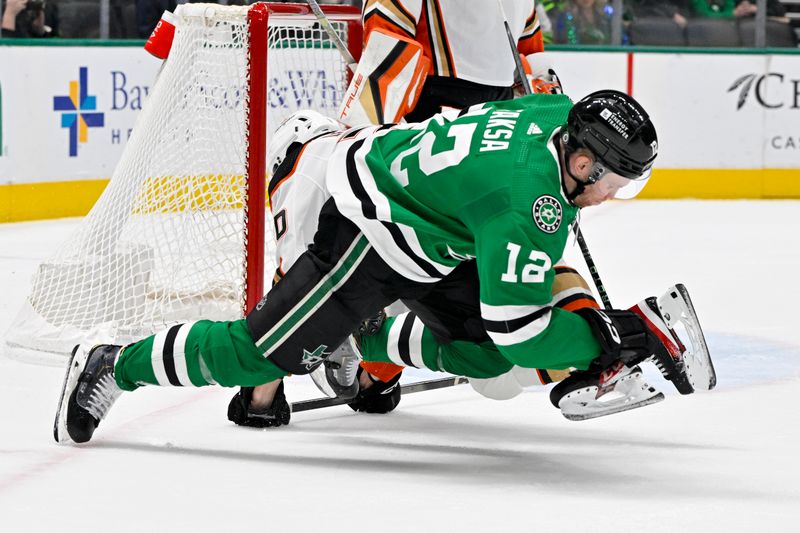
[575,307,663,368]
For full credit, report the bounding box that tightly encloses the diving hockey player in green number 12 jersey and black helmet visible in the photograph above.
[55,91,708,442]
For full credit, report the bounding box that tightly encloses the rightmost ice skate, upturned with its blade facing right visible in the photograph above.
[631,283,717,394]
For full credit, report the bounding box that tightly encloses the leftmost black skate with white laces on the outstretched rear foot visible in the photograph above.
[53,344,122,443]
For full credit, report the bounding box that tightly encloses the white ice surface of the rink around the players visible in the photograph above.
[0,201,800,533]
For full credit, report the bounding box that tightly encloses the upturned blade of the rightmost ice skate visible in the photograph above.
[658,283,717,390]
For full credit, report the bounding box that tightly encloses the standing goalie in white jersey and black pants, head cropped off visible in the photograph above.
[362,0,560,122]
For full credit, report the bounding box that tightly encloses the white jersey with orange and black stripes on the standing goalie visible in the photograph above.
[362,0,544,87]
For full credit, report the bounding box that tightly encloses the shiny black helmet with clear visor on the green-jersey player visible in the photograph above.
[563,89,658,197]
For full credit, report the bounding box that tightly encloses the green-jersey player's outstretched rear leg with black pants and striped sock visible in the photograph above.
[56,201,408,442]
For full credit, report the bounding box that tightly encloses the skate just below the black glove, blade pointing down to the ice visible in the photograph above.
[550,361,664,420]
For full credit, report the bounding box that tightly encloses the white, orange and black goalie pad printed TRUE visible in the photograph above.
[339,28,430,126]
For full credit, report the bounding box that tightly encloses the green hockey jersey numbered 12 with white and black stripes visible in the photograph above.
[328,95,600,368]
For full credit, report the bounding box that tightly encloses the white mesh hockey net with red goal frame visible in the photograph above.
[5,4,361,364]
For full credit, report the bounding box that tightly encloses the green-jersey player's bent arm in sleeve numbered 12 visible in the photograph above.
[475,212,601,369]
